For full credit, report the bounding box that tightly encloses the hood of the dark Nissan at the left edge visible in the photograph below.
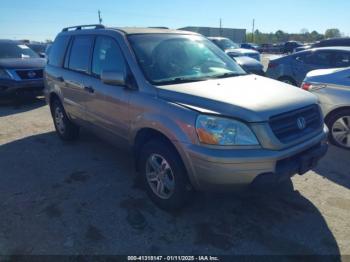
[0,58,46,69]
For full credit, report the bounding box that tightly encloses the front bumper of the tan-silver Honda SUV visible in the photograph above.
[180,127,328,191]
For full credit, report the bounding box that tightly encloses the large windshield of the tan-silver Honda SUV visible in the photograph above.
[129,34,245,85]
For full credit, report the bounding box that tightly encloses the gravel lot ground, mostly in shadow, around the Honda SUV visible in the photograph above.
[0,99,350,255]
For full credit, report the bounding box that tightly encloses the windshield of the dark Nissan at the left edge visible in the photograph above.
[0,43,39,58]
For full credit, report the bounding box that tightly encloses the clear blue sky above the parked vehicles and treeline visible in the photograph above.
[0,0,350,40]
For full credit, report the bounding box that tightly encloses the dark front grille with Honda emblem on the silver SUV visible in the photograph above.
[269,105,322,143]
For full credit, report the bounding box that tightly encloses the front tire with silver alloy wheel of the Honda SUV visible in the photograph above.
[138,139,193,211]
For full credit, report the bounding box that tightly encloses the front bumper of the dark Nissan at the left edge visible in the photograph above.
[0,79,44,97]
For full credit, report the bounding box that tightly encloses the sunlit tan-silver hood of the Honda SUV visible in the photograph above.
[157,75,317,122]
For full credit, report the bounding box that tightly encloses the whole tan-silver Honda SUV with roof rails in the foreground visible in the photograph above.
[45,25,327,209]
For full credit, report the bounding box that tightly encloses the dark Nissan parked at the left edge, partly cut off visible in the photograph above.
[0,40,46,97]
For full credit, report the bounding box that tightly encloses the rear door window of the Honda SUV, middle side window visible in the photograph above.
[68,36,94,73]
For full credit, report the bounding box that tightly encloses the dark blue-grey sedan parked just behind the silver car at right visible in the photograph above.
[266,47,350,86]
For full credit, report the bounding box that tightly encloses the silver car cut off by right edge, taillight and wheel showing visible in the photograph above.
[302,67,350,149]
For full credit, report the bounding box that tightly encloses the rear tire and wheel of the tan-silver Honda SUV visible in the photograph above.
[51,99,80,141]
